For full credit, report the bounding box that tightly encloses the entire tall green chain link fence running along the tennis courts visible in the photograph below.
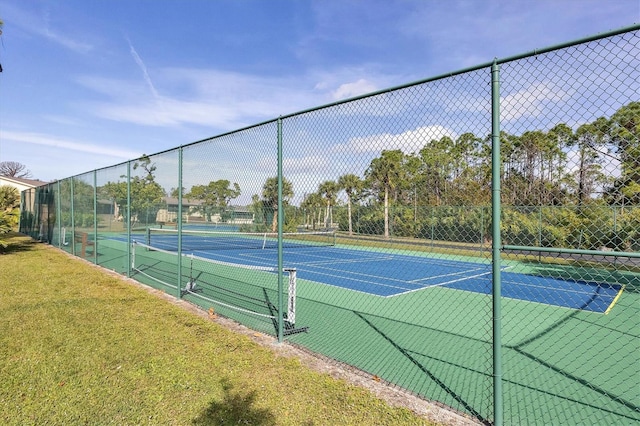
[21,26,640,425]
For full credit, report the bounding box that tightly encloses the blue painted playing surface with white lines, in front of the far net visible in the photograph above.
[162,243,622,313]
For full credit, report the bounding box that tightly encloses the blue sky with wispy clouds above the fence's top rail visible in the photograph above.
[0,0,640,186]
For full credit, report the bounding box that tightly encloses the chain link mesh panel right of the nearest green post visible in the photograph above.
[501,31,640,424]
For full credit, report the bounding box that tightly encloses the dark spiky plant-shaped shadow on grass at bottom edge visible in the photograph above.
[191,379,276,426]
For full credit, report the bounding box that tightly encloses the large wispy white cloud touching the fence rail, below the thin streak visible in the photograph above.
[77,64,404,130]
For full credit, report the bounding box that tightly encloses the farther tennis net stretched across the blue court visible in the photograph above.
[146,228,336,251]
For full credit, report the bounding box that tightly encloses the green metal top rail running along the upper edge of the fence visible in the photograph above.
[36,23,640,183]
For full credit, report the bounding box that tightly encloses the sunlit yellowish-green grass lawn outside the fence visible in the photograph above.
[0,234,440,425]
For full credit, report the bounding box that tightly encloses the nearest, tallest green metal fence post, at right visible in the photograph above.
[491,61,503,426]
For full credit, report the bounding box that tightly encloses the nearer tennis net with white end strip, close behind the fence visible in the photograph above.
[131,241,306,335]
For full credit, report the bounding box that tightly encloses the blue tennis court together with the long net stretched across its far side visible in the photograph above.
[136,230,623,313]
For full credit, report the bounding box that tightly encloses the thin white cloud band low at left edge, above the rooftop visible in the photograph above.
[2,130,141,160]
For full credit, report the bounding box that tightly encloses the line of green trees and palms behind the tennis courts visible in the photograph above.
[43,102,640,249]
